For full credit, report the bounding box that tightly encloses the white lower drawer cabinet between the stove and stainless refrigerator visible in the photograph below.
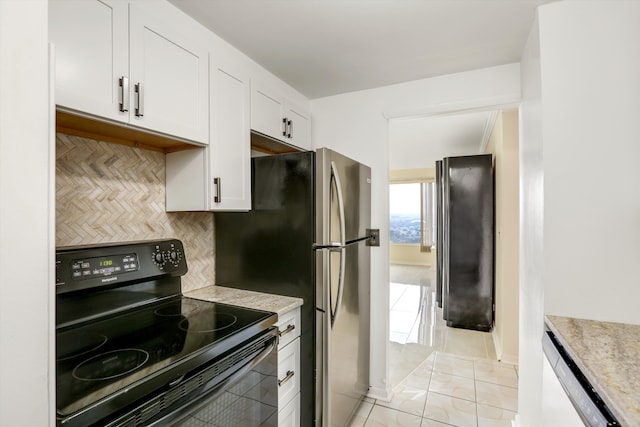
[277,308,300,427]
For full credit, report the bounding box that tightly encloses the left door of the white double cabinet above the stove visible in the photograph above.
[49,0,129,122]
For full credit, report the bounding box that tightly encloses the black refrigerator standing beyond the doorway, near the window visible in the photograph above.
[436,154,494,332]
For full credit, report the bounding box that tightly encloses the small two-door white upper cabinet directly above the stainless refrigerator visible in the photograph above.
[251,84,311,150]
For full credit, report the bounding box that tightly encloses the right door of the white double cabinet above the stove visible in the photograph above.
[129,4,209,144]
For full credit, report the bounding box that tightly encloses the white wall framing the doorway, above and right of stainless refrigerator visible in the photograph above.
[311,64,520,398]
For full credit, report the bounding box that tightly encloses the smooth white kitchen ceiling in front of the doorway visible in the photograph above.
[169,0,552,99]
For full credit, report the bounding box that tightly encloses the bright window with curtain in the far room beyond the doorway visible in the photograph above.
[389,182,436,252]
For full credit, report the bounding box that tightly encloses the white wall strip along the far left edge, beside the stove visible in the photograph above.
[0,0,55,426]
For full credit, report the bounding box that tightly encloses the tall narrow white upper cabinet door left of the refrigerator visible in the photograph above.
[208,56,251,211]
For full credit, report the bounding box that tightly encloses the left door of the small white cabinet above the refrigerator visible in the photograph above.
[251,87,285,140]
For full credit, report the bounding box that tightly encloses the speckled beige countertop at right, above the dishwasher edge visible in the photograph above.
[547,316,640,426]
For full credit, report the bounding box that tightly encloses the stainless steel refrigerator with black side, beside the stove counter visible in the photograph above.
[214,148,371,426]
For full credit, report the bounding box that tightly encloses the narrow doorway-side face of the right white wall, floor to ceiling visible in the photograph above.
[516,15,544,427]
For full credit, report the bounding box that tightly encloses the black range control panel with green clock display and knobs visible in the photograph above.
[56,239,187,293]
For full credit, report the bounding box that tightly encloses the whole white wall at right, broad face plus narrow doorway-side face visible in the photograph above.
[517,0,640,427]
